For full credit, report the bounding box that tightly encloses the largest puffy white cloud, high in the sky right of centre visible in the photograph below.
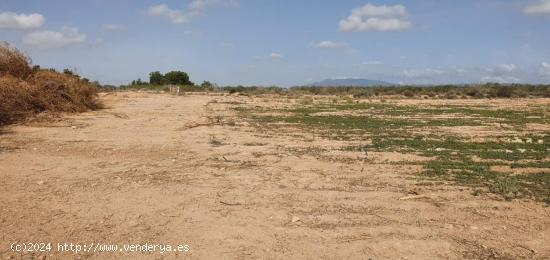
[340,4,412,32]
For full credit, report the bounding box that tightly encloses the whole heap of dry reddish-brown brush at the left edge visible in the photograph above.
[0,43,102,125]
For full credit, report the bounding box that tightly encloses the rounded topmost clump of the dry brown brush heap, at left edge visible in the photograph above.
[0,42,33,79]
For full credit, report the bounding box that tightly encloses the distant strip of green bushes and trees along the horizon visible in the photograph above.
[102,70,550,99]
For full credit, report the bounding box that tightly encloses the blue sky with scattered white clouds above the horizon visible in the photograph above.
[0,0,550,86]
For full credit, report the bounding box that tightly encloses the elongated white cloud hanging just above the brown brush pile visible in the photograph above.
[23,27,86,49]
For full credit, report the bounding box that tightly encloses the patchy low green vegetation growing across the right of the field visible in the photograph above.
[235,97,550,203]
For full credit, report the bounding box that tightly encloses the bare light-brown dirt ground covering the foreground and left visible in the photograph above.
[0,92,550,259]
